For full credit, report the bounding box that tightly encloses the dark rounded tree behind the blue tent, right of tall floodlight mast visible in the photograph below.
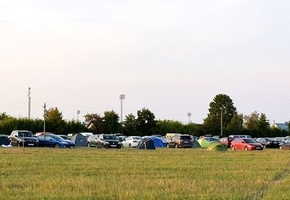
[136,108,156,135]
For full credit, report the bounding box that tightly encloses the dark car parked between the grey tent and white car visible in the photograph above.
[97,134,122,149]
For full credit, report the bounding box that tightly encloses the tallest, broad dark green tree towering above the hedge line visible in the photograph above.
[203,94,237,135]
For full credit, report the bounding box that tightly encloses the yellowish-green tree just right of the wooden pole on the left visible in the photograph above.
[44,107,66,134]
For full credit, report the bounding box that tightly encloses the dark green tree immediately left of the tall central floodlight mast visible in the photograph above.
[104,110,121,134]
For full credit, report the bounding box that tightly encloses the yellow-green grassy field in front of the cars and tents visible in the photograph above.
[0,147,290,200]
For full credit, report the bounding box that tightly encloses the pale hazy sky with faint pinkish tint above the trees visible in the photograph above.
[0,0,290,123]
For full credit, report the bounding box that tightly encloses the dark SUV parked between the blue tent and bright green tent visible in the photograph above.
[167,134,193,148]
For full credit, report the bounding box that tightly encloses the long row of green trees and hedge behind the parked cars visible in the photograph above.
[0,94,290,137]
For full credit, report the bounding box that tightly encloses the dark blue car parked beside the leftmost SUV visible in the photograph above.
[37,134,75,148]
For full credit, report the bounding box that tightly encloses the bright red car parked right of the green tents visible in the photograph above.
[231,138,263,151]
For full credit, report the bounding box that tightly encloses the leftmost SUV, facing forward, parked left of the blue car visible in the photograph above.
[9,130,39,147]
